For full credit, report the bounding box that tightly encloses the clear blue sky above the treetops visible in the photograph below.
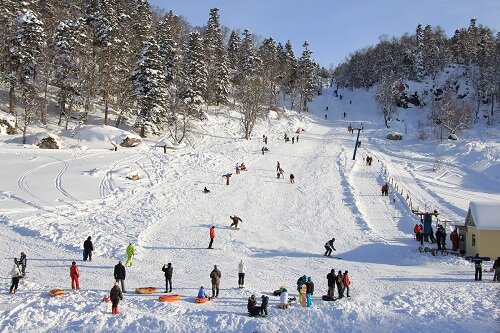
[150,0,500,68]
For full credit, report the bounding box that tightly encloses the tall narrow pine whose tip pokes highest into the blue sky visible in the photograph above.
[204,8,229,105]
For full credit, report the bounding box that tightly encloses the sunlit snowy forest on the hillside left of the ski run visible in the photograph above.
[0,0,318,142]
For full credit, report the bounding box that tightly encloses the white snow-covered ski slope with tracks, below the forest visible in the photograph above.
[0,89,500,332]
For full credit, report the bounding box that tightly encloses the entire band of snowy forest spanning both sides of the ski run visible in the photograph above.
[0,0,500,142]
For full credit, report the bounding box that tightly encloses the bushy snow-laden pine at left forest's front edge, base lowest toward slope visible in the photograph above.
[132,37,169,137]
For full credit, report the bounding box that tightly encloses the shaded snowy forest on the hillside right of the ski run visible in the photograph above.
[334,18,500,130]
